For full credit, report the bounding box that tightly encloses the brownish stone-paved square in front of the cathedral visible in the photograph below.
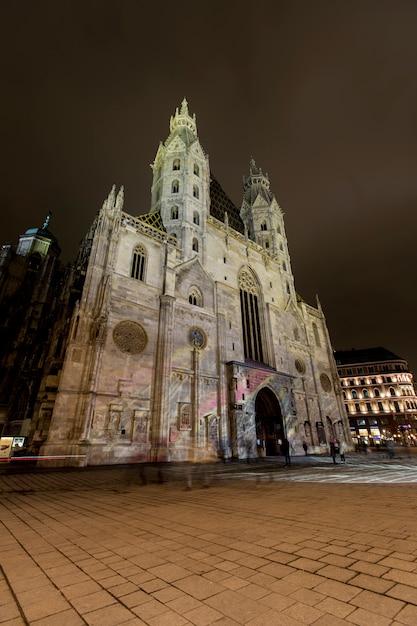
[0,455,417,626]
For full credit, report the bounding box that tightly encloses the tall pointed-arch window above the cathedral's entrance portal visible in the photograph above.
[239,268,265,363]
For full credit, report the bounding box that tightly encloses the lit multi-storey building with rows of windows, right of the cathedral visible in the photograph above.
[335,348,417,445]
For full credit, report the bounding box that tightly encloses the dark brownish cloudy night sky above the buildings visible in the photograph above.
[0,0,417,376]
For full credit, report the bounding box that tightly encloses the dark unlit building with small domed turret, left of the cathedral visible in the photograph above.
[0,214,82,450]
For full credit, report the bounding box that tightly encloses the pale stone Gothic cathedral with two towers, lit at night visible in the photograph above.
[18,99,350,466]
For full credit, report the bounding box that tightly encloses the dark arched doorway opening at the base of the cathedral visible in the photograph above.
[255,387,284,456]
